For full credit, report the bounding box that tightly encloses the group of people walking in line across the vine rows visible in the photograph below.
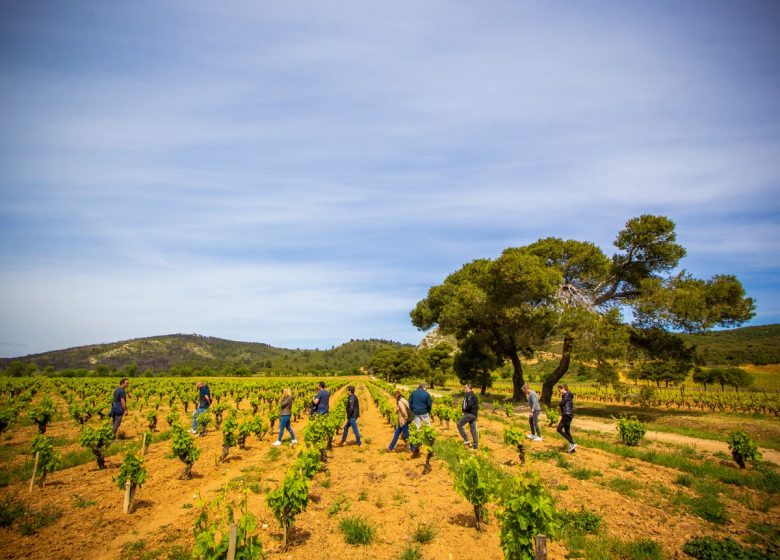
[109,378,577,453]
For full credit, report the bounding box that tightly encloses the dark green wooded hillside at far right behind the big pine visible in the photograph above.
[682,325,780,366]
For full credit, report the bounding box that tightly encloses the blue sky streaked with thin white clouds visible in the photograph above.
[0,0,780,357]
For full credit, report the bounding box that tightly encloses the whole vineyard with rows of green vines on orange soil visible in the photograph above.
[0,378,780,560]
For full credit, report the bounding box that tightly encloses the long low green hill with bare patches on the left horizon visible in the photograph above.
[0,334,412,374]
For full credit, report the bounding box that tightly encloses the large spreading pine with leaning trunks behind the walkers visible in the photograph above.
[411,215,754,406]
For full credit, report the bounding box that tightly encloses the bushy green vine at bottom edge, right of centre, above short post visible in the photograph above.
[496,473,558,560]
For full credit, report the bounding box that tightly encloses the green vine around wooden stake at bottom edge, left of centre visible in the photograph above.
[192,494,263,560]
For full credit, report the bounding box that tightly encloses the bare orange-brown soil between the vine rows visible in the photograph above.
[0,385,780,560]
